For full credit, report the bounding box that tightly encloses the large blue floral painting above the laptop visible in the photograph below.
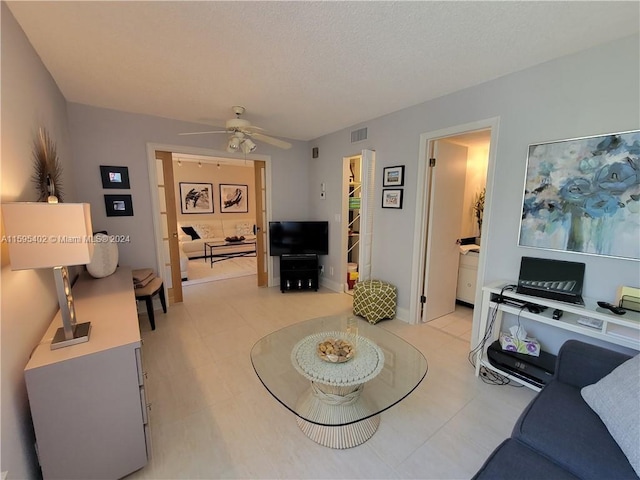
[519,130,640,260]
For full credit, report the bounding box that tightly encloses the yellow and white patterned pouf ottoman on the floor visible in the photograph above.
[353,280,398,324]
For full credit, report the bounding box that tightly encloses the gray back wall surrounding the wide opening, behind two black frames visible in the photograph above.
[68,103,311,268]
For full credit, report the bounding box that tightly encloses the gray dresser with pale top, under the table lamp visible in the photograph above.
[24,267,150,479]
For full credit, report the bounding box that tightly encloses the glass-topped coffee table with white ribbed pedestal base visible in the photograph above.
[251,315,427,448]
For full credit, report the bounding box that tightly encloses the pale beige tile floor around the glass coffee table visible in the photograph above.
[128,277,534,479]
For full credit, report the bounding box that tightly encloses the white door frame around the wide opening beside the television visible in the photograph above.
[147,143,274,287]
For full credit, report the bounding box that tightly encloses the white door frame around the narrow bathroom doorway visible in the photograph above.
[409,117,500,343]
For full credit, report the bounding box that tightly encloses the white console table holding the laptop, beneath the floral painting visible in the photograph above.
[475,281,640,391]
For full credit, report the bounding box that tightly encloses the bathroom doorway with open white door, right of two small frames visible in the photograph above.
[410,118,498,323]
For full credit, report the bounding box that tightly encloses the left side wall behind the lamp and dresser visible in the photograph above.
[0,2,77,478]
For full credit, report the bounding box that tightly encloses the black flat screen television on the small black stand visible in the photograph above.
[269,222,329,257]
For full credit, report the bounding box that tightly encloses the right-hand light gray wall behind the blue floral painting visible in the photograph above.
[309,36,640,320]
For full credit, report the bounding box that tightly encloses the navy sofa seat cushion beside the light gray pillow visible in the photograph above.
[513,380,637,480]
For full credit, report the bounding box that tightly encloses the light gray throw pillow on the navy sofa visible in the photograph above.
[580,355,640,476]
